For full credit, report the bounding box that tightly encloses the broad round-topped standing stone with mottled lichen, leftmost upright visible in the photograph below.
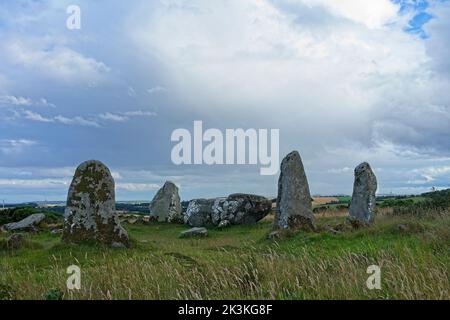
[63,160,128,245]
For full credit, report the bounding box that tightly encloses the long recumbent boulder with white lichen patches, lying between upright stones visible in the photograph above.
[184,193,272,228]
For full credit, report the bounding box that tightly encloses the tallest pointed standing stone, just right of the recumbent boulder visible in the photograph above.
[274,151,314,230]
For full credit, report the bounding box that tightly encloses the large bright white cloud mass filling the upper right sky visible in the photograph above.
[128,0,450,154]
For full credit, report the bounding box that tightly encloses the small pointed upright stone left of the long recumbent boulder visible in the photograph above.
[150,181,183,223]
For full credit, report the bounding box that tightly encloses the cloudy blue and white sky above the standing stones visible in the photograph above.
[0,0,450,203]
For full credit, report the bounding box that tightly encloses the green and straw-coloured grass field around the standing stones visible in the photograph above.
[0,212,450,299]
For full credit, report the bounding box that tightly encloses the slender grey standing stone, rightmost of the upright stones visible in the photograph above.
[349,162,377,224]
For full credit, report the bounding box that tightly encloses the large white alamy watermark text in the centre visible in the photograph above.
[171,121,280,175]
